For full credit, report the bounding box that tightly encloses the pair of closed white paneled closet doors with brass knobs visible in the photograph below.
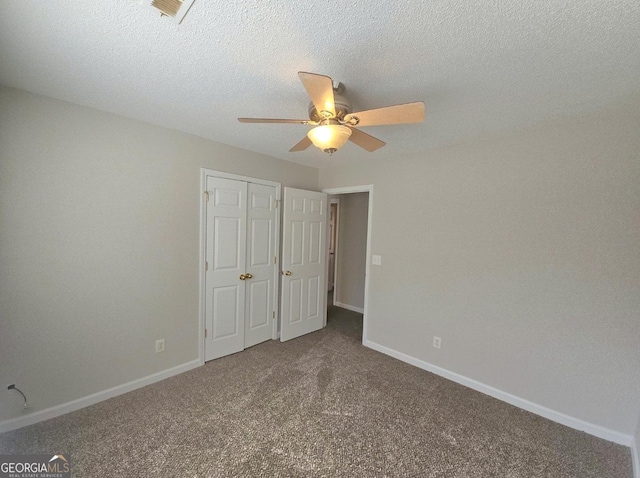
[205,176,278,360]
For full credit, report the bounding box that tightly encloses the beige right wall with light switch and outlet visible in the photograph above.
[320,109,640,437]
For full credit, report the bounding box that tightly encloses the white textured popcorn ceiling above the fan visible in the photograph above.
[0,0,640,167]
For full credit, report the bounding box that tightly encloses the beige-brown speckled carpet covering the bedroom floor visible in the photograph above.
[0,308,632,478]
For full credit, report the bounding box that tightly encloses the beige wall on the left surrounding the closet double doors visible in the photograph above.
[0,88,318,421]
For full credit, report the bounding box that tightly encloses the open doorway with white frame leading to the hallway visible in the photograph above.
[323,185,373,342]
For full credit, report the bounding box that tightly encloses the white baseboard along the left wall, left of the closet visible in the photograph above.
[0,360,202,433]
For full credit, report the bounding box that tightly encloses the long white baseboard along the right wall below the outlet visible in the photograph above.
[363,339,640,446]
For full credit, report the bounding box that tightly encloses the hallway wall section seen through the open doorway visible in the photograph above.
[334,193,369,309]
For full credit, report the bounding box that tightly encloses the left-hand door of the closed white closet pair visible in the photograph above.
[205,176,247,360]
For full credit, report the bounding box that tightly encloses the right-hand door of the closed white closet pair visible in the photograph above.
[244,183,278,348]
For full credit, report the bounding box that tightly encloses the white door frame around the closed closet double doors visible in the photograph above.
[198,168,282,365]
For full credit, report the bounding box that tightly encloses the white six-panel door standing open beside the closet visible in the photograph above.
[280,188,327,342]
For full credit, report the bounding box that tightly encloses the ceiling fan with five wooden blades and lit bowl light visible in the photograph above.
[238,71,424,154]
